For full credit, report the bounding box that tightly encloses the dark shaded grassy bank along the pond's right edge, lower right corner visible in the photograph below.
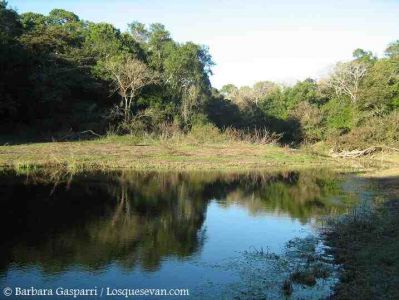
[326,173,399,299]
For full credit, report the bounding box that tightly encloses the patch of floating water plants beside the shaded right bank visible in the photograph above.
[196,235,338,299]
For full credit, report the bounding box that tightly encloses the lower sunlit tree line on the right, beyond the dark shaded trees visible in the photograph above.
[220,46,399,147]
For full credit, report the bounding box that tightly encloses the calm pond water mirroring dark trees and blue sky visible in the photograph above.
[0,170,374,299]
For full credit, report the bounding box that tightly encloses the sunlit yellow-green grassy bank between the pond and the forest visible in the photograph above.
[0,136,396,171]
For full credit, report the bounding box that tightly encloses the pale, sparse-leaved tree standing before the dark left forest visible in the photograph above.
[105,56,159,122]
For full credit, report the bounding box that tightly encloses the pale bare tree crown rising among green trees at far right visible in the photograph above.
[328,62,367,103]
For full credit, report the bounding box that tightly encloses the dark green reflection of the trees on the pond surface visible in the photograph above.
[0,170,351,273]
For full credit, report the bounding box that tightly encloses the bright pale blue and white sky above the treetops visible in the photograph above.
[8,0,399,87]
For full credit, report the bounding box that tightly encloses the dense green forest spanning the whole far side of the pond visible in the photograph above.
[0,1,399,148]
